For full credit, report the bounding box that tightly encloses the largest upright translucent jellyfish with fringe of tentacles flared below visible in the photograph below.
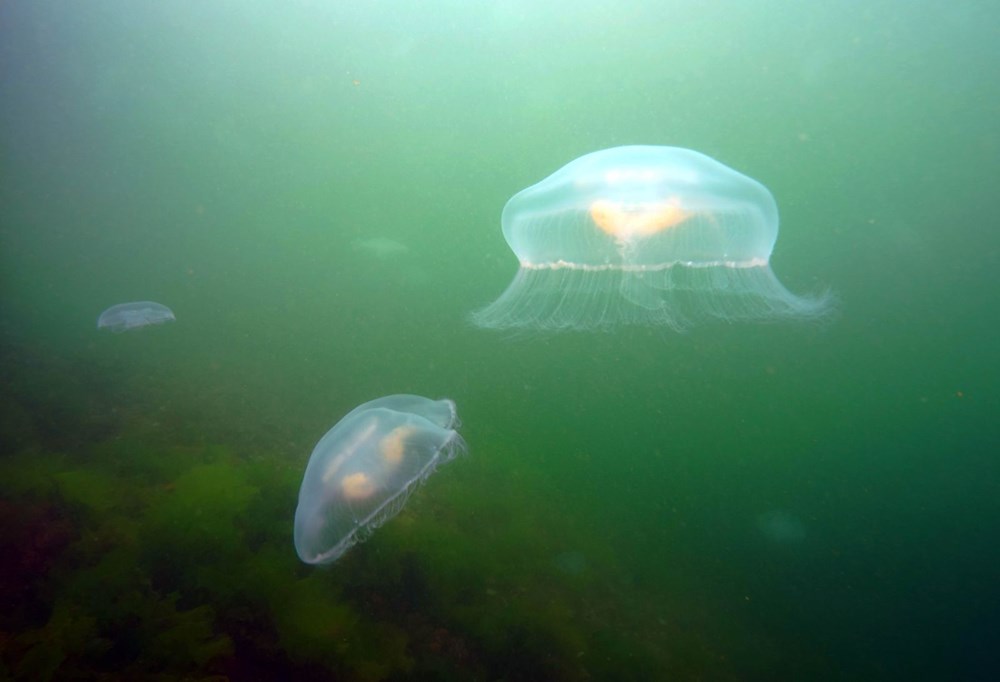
[471,146,830,331]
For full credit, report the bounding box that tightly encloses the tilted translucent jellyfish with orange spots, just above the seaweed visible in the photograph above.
[294,395,465,564]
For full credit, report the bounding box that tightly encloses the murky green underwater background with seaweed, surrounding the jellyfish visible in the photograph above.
[0,0,1000,680]
